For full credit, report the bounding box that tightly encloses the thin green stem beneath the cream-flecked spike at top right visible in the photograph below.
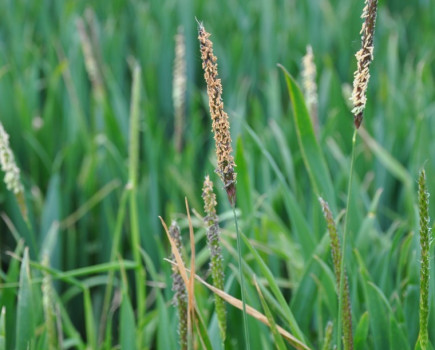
[337,129,358,350]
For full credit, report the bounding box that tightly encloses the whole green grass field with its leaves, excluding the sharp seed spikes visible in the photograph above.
[0,0,435,350]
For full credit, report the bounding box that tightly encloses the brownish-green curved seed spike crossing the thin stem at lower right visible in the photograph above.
[319,197,353,350]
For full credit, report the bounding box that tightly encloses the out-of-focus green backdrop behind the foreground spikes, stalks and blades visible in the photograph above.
[0,0,435,349]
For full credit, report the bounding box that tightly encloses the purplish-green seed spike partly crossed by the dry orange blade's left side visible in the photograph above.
[169,221,188,350]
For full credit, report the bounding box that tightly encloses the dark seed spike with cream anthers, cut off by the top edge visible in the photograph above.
[352,0,378,129]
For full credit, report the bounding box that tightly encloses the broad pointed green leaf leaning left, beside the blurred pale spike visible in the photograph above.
[280,66,337,212]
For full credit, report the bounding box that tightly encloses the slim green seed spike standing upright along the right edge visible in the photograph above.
[416,169,432,350]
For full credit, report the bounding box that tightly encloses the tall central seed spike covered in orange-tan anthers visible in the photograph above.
[198,23,237,205]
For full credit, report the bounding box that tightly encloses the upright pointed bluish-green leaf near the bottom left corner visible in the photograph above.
[16,248,36,350]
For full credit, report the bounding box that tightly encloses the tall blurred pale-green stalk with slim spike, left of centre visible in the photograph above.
[127,63,146,349]
